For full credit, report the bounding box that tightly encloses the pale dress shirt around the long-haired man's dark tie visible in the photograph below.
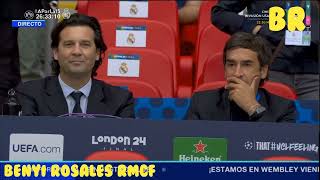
[58,75,92,113]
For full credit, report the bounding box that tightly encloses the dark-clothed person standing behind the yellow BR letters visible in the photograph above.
[212,0,319,100]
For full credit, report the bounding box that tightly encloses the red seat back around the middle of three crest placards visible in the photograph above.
[100,19,179,97]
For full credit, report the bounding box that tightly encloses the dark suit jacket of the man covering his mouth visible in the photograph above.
[188,88,296,122]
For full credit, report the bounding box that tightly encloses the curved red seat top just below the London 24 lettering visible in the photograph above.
[85,151,148,161]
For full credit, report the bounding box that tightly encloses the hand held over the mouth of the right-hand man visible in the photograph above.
[225,76,260,115]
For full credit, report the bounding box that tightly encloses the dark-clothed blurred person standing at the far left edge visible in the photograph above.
[0,0,57,108]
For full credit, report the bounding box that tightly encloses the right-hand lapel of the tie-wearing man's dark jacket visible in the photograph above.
[87,79,114,115]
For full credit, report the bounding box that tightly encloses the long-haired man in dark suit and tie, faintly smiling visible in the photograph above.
[17,14,134,117]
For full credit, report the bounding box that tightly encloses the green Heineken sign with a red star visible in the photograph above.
[173,137,227,161]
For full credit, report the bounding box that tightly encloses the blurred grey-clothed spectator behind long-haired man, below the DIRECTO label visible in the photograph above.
[18,0,58,81]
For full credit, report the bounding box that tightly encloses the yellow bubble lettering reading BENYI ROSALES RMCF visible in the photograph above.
[3,164,156,177]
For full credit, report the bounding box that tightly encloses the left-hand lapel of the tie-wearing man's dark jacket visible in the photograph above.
[44,77,68,115]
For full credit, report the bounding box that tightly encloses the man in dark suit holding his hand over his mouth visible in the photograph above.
[188,32,295,122]
